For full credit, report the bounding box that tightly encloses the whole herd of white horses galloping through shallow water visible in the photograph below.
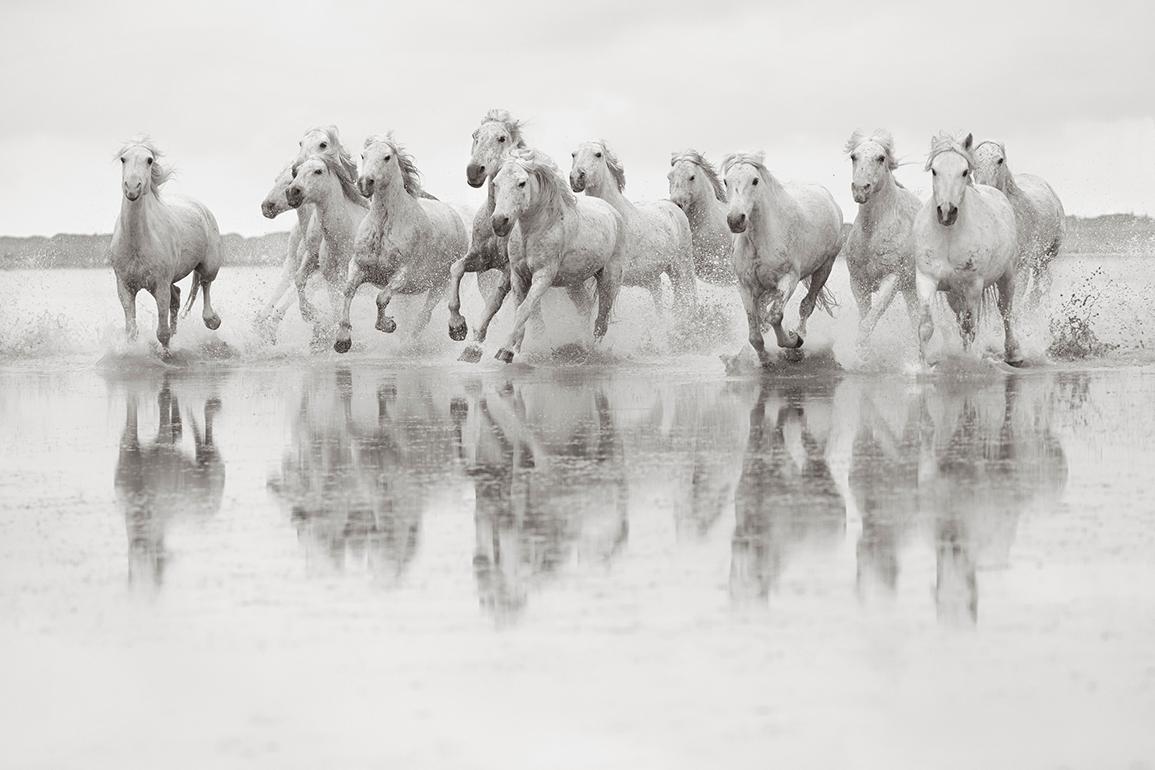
[111,110,1064,365]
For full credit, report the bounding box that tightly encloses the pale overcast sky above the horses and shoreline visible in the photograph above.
[0,0,1155,234]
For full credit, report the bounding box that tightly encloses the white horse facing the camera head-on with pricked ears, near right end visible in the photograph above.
[911,134,1022,366]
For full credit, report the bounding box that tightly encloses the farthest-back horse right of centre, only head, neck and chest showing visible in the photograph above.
[666,150,733,285]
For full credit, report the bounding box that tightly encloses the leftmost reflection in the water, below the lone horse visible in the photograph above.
[116,375,225,585]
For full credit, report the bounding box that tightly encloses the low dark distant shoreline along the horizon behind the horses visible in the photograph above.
[0,212,1155,270]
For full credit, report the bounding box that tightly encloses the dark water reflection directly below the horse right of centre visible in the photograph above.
[730,377,845,600]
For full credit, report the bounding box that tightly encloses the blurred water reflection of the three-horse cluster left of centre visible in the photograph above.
[269,368,453,583]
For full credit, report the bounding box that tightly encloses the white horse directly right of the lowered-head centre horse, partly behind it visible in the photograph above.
[569,140,698,315]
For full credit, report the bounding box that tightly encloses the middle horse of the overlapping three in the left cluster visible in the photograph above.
[285,155,367,320]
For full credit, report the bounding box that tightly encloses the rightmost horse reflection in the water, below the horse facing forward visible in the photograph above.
[918,376,1067,623]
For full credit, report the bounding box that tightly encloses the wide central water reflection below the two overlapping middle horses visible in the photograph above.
[457,381,628,620]
